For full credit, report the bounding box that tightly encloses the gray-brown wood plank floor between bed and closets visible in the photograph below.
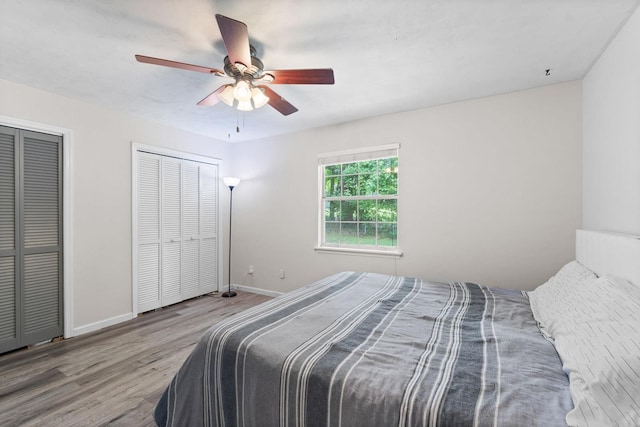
[0,292,270,427]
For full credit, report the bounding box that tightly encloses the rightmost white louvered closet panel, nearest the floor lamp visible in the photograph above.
[200,164,219,293]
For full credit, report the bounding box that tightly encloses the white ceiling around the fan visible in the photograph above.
[0,0,638,142]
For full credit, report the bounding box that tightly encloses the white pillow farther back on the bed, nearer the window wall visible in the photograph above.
[528,261,598,337]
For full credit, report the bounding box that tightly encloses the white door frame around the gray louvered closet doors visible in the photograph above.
[0,115,74,338]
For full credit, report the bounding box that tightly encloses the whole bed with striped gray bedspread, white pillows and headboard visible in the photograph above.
[155,231,640,426]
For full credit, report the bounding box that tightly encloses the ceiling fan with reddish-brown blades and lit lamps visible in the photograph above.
[136,14,335,116]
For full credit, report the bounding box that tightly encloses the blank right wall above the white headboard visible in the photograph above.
[583,9,640,234]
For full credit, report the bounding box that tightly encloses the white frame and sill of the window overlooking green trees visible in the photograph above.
[315,143,402,257]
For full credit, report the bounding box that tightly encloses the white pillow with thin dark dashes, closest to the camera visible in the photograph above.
[554,276,640,426]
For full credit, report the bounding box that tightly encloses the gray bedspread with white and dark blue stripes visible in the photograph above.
[155,272,572,426]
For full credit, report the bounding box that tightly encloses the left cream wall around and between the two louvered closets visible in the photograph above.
[0,80,230,331]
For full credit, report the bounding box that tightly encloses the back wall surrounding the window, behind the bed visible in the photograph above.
[232,82,582,291]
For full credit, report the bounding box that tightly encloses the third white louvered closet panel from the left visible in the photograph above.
[182,160,202,299]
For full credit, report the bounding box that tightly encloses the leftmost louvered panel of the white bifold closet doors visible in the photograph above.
[137,153,161,313]
